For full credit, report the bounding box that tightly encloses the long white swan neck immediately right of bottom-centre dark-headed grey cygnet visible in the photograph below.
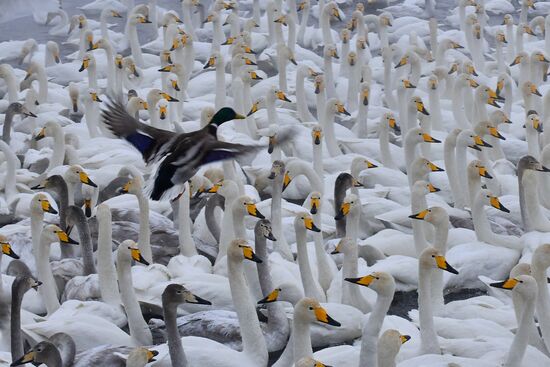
[227,256,268,366]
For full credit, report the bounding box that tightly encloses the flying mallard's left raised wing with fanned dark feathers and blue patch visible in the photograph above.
[101,100,176,163]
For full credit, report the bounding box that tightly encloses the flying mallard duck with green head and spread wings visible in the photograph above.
[102,102,268,200]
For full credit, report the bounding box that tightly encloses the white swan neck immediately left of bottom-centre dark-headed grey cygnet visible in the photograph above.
[116,249,153,345]
